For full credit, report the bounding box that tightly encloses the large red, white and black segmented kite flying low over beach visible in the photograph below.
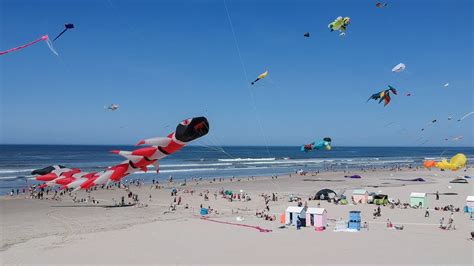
[31,117,209,191]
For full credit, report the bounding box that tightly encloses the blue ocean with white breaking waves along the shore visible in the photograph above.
[0,145,474,194]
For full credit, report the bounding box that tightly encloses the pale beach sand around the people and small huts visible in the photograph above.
[0,169,474,265]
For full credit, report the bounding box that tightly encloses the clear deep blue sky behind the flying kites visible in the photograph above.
[0,0,474,146]
